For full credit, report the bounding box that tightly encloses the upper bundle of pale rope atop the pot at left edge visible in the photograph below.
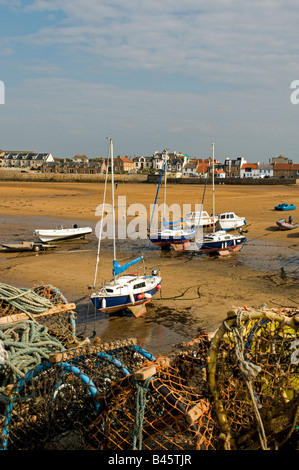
[0,282,54,314]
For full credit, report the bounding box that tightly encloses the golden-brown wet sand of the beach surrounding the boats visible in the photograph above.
[0,182,299,354]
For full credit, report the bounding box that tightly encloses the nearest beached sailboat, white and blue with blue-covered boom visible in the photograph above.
[90,139,162,317]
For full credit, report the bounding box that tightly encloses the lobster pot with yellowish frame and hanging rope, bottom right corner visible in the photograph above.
[209,308,299,449]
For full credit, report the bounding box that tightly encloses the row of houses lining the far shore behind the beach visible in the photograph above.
[0,150,299,178]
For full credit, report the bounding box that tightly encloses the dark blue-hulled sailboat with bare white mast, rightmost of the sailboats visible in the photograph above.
[191,143,246,255]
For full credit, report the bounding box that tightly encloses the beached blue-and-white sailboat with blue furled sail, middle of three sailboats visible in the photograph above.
[148,152,196,249]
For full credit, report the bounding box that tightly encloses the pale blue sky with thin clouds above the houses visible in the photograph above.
[0,0,299,163]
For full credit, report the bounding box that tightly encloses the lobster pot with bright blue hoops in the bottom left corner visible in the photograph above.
[0,339,152,450]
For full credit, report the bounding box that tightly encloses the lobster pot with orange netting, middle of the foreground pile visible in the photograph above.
[90,332,217,451]
